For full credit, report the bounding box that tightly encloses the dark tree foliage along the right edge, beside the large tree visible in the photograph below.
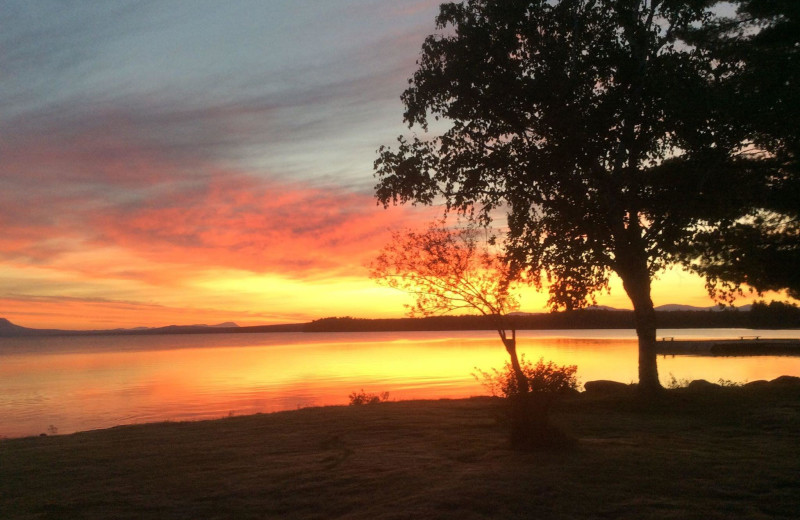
[685,0,800,300]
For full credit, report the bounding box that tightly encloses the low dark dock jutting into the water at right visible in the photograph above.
[656,336,800,356]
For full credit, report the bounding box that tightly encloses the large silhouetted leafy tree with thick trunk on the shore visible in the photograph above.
[375,0,800,390]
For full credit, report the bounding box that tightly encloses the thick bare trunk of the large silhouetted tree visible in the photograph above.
[619,258,662,393]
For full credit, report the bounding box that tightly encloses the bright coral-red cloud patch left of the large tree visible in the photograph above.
[91,173,438,276]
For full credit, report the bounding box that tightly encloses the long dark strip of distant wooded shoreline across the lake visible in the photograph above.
[0,301,800,337]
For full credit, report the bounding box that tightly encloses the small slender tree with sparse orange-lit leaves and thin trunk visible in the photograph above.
[370,223,528,394]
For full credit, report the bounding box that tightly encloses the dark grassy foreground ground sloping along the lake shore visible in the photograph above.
[0,383,800,519]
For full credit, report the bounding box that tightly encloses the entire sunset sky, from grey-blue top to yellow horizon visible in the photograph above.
[0,0,776,328]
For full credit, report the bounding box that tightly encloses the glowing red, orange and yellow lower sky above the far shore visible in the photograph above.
[0,165,788,329]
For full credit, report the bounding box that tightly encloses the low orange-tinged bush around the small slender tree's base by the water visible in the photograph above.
[472,355,578,397]
